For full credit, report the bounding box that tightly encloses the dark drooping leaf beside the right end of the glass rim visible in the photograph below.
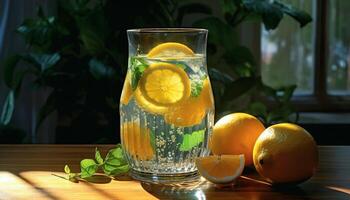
[193,17,237,52]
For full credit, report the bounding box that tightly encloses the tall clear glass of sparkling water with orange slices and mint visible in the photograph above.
[120,28,214,183]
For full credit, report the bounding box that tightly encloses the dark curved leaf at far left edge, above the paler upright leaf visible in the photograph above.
[3,54,21,88]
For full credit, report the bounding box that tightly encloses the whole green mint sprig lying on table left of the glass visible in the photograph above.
[64,145,129,182]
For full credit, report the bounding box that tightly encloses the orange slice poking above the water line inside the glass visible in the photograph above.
[147,42,194,58]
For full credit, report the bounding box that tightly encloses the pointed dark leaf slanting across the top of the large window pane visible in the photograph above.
[274,0,312,27]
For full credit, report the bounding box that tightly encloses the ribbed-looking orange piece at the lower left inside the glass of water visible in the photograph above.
[121,121,154,160]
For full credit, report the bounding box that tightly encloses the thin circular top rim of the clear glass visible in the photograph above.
[126,28,208,33]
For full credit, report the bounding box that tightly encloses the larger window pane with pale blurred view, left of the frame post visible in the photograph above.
[261,0,314,95]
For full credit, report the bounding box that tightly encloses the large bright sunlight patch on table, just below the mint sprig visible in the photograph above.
[19,171,154,200]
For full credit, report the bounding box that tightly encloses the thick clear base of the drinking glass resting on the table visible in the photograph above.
[130,170,200,184]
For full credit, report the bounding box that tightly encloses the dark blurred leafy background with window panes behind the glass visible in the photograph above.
[0,0,350,143]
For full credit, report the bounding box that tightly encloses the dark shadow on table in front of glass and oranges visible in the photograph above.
[141,176,322,200]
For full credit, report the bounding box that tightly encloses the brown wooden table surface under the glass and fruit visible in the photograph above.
[0,145,350,200]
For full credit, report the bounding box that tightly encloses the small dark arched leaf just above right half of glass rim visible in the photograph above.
[176,3,212,24]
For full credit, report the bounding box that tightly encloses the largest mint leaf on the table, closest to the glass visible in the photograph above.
[102,145,129,176]
